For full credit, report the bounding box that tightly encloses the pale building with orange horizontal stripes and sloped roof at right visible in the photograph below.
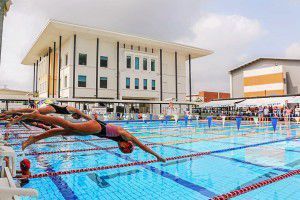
[229,58,300,98]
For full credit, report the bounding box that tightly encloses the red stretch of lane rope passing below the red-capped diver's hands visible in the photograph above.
[30,151,211,178]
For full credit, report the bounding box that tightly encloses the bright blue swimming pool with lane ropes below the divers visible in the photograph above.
[2,121,300,200]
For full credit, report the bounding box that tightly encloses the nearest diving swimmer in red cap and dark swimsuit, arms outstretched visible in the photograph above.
[13,111,166,162]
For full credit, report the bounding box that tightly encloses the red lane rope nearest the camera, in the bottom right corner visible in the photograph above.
[212,169,300,200]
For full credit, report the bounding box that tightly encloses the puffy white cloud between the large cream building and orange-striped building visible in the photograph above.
[180,14,266,92]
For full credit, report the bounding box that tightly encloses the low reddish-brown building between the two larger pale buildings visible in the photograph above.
[186,91,230,102]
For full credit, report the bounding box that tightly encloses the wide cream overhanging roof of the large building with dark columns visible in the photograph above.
[22,20,213,65]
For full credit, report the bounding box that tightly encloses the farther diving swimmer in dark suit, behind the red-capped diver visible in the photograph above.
[0,104,92,120]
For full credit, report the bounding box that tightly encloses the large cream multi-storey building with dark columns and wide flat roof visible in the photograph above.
[22,20,212,113]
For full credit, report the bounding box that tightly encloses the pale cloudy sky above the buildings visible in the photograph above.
[0,0,300,93]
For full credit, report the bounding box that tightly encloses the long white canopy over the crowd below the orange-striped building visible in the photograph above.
[236,97,293,108]
